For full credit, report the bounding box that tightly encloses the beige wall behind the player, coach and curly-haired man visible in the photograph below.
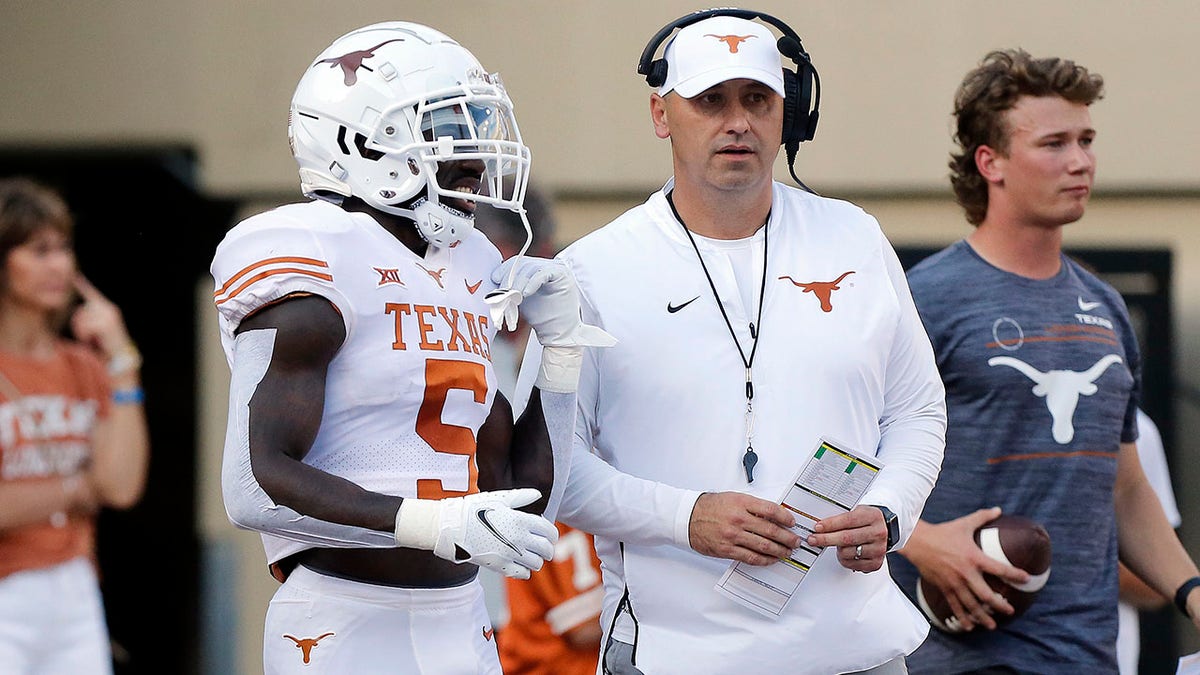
[0,0,1200,673]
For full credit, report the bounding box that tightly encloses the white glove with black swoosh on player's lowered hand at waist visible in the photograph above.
[396,488,558,579]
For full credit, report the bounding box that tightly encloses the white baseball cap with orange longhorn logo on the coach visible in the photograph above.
[659,17,786,98]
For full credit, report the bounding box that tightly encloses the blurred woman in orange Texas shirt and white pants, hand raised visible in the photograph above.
[0,179,149,674]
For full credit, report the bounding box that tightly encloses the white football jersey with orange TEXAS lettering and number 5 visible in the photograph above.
[212,201,500,562]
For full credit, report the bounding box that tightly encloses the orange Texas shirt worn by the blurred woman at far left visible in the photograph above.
[0,341,112,578]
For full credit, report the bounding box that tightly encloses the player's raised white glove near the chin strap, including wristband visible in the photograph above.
[485,256,617,394]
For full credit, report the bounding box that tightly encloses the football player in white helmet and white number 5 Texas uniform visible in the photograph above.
[211,22,606,674]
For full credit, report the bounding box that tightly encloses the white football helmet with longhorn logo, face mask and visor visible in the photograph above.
[288,22,530,246]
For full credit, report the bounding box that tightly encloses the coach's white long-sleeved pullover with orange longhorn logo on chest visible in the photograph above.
[559,183,946,674]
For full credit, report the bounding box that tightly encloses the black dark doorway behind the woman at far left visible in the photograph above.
[0,147,236,675]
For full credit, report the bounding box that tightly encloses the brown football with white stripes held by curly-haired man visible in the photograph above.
[917,515,1050,633]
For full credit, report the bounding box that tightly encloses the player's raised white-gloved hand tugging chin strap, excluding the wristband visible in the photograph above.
[485,256,617,347]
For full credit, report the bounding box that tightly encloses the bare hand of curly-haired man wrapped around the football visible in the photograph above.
[900,507,1030,631]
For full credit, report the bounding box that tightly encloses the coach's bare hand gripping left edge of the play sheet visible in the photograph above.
[688,492,800,566]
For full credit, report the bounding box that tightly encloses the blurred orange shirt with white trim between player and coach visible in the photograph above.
[496,522,604,675]
